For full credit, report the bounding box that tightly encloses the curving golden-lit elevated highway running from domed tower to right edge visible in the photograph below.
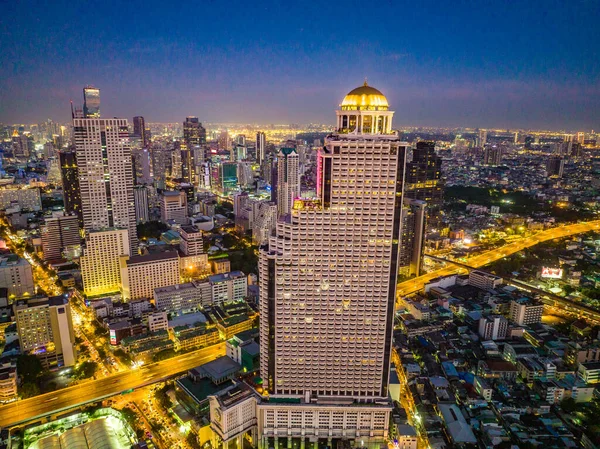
[396,220,600,305]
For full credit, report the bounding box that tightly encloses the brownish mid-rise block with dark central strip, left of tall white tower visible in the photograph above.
[42,215,81,261]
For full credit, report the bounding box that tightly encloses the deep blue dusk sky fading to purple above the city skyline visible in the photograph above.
[0,0,600,130]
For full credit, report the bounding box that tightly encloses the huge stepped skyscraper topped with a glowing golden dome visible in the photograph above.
[258,83,407,447]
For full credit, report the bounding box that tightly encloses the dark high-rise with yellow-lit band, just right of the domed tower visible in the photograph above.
[404,141,444,228]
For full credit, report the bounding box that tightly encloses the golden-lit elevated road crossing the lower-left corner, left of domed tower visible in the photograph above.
[0,343,225,427]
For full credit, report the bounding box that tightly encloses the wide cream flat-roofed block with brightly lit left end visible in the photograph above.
[120,251,180,300]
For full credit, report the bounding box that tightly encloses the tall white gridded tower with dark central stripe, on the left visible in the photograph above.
[73,110,138,254]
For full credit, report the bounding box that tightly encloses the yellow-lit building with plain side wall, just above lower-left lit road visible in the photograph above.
[13,296,77,368]
